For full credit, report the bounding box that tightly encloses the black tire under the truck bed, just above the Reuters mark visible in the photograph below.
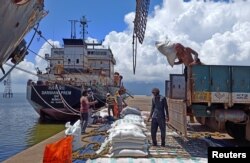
[225,121,246,140]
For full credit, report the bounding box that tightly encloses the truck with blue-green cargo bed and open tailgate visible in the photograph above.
[165,65,250,141]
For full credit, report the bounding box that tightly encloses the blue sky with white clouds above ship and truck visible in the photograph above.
[0,0,250,94]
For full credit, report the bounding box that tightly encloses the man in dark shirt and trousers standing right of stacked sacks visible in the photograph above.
[148,88,168,147]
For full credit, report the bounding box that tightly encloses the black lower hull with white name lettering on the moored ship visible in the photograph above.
[27,81,119,121]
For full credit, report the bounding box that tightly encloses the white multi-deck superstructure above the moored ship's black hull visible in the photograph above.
[38,39,116,86]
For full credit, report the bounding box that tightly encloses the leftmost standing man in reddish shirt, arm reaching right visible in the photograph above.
[80,90,98,134]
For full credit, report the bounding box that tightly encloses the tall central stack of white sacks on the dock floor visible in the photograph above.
[108,107,149,157]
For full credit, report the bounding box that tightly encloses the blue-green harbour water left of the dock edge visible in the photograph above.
[0,93,65,162]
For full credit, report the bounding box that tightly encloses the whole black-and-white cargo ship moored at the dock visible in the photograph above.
[27,17,124,121]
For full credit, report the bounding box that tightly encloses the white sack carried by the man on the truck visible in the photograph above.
[155,40,177,67]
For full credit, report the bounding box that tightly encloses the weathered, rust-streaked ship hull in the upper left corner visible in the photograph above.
[0,0,46,66]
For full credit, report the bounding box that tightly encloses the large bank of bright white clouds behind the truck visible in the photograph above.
[104,0,250,83]
